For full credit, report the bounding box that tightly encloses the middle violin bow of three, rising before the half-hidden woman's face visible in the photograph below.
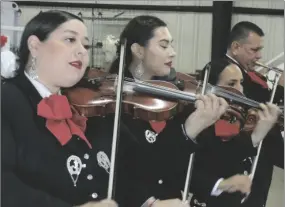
[182,64,211,203]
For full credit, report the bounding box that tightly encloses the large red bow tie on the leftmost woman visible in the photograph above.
[38,95,92,148]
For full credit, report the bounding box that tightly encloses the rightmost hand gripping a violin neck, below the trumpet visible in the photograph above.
[251,103,281,146]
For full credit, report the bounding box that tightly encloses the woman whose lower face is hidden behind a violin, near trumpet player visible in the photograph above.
[186,60,279,207]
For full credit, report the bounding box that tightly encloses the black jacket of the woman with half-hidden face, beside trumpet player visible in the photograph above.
[187,126,257,207]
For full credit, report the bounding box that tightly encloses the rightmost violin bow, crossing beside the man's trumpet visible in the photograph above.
[241,68,281,203]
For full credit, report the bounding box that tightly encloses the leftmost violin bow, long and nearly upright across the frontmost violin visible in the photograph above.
[107,39,127,199]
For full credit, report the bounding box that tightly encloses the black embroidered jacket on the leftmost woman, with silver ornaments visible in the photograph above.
[1,74,138,207]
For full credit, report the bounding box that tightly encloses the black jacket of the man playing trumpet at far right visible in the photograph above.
[225,56,284,207]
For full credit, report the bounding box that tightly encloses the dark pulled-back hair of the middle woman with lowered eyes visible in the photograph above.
[110,15,167,77]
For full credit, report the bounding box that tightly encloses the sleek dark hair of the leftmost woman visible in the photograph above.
[17,10,83,77]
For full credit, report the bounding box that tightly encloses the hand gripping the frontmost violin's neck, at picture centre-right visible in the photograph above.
[185,94,228,138]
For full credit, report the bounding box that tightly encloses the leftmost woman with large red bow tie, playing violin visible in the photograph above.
[1,11,227,207]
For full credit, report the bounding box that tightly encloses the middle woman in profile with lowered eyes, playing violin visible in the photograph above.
[106,16,231,206]
